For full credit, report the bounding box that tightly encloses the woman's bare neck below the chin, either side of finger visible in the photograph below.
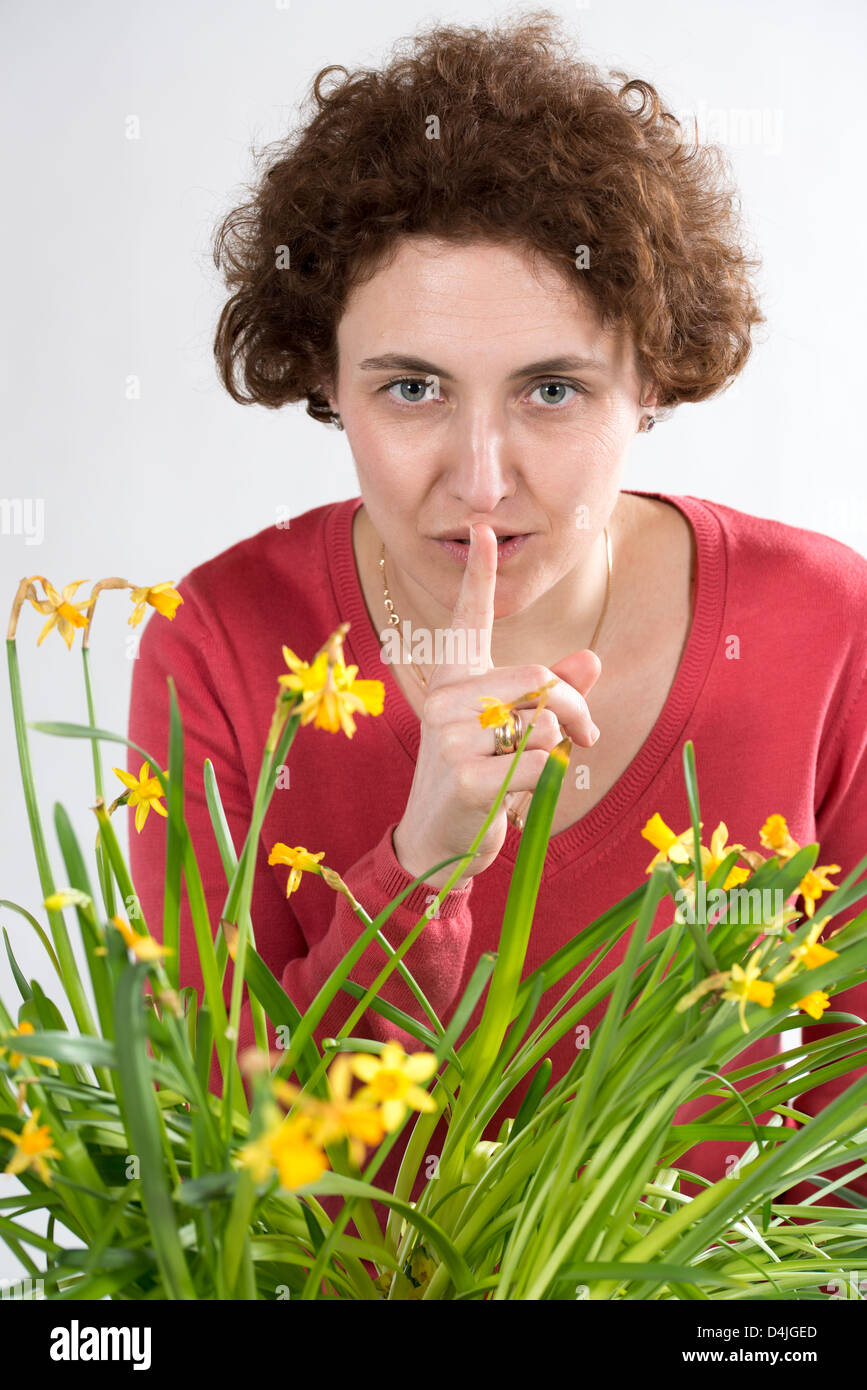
[357,493,622,676]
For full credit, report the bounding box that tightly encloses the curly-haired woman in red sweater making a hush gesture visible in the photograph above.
[129,13,867,1228]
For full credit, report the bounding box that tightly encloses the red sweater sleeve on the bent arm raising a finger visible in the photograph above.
[128,582,472,1094]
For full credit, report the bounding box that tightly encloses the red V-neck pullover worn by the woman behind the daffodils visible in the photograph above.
[128,489,867,1239]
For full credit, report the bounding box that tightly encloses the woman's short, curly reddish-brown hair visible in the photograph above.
[213,10,766,421]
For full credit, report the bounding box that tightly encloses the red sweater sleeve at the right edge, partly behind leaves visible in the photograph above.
[789,656,867,1205]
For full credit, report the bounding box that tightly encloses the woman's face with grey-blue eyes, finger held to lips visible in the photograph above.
[331,238,653,617]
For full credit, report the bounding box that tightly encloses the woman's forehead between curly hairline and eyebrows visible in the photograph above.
[338,236,624,361]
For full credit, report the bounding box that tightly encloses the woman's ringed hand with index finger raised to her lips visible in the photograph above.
[392,524,602,890]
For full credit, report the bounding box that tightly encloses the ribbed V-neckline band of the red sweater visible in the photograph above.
[325,488,727,876]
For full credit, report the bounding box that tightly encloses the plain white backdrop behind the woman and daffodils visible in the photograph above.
[0,0,867,1279]
